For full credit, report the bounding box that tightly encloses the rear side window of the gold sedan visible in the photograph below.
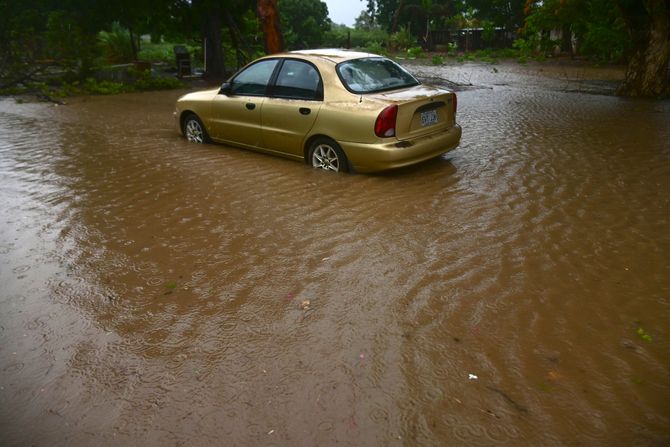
[272,59,323,100]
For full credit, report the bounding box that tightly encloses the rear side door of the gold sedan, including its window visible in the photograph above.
[261,59,323,157]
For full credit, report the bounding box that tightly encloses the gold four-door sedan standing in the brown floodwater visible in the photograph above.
[175,50,461,172]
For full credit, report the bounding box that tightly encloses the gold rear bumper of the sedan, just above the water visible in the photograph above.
[338,124,461,172]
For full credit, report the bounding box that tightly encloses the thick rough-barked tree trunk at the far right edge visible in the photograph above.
[617,0,670,97]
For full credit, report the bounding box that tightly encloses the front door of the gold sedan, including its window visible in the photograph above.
[210,59,279,147]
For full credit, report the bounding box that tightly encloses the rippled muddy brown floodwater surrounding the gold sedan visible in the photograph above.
[0,60,670,446]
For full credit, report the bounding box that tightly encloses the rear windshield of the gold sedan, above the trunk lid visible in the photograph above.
[337,57,419,93]
